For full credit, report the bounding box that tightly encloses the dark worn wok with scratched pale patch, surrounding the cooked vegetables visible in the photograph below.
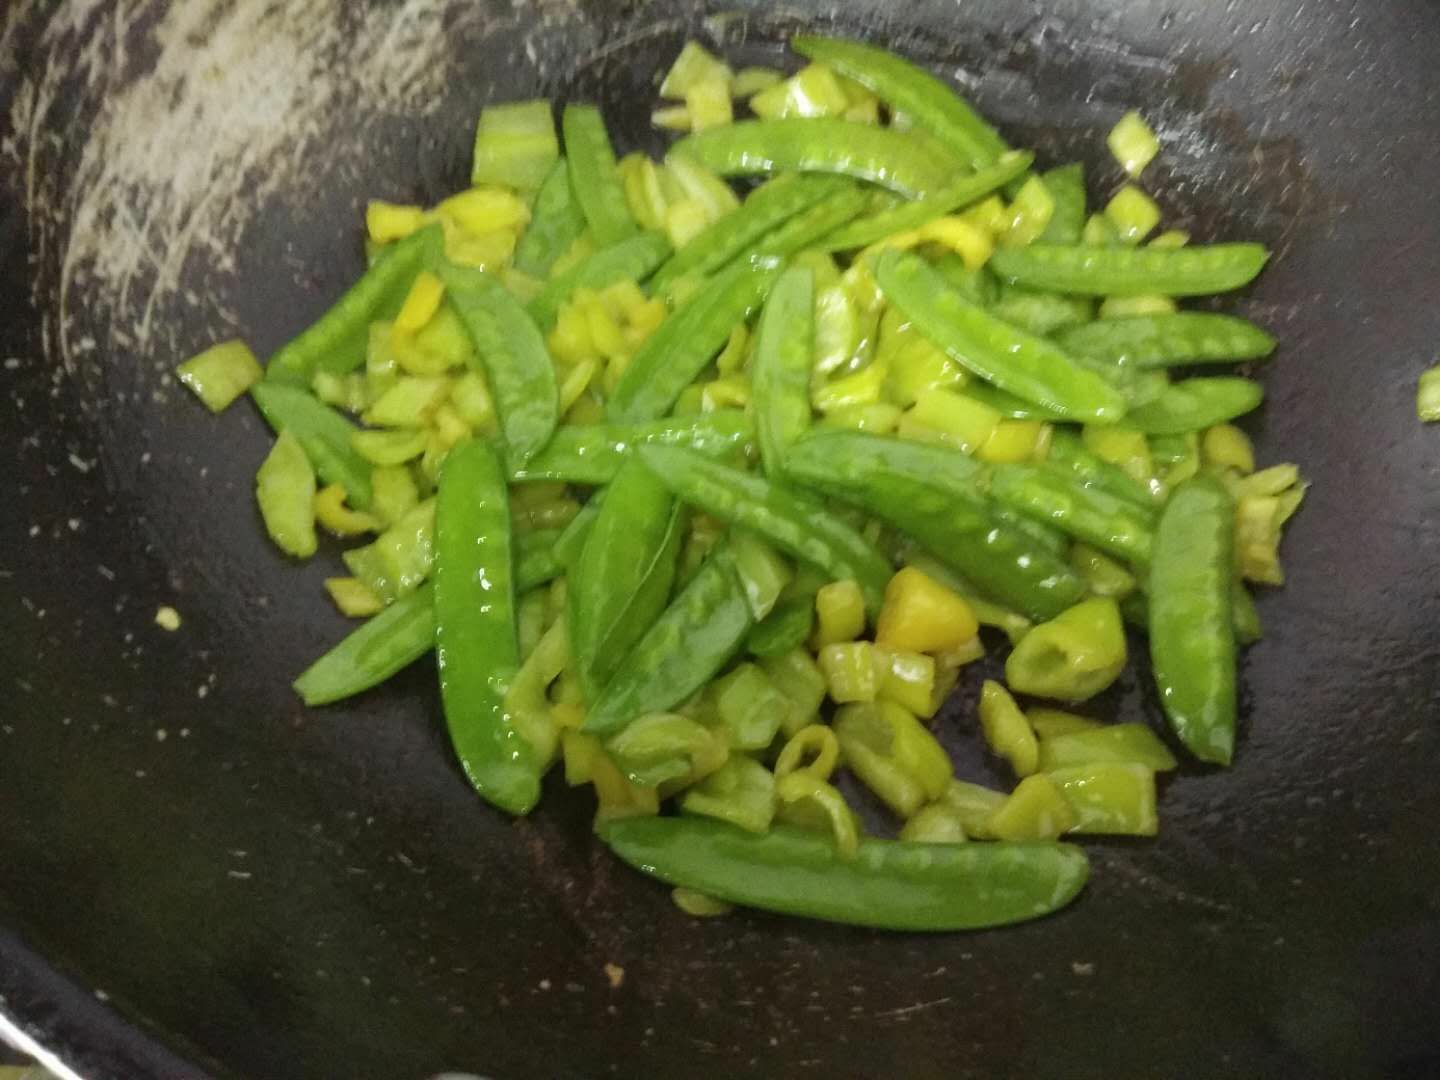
[0,0,1440,1080]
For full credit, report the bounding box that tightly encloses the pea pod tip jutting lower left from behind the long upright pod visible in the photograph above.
[294,582,435,706]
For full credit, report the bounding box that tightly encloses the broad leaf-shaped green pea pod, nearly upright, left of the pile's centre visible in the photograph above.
[566,458,683,700]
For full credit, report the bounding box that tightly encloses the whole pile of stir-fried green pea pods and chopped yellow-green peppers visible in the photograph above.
[181,36,1305,929]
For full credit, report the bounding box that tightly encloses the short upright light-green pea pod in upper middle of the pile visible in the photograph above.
[750,266,815,480]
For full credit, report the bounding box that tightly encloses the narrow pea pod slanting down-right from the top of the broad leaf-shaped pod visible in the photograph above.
[639,446,893,618]
